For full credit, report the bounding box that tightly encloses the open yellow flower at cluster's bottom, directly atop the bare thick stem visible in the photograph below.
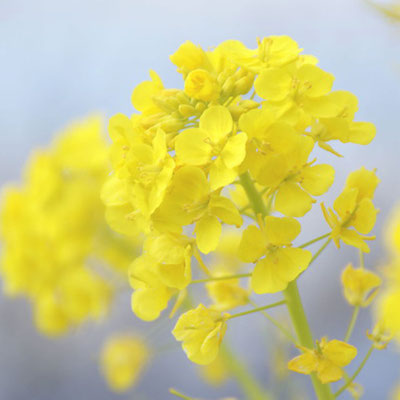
[239,216,312,294]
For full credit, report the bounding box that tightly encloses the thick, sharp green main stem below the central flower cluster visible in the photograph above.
[283,281,333,400]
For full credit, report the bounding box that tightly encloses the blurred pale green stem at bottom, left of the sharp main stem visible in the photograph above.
[220,344,270,400]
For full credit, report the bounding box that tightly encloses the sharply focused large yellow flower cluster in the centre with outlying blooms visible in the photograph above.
[102,36,380,398]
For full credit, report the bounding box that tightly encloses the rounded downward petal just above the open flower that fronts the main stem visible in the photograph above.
[275,183,314,217]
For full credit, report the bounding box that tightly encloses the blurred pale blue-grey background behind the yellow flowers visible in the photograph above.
[0,0,400,400]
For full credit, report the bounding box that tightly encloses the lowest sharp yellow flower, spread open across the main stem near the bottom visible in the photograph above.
[288,338,357,383]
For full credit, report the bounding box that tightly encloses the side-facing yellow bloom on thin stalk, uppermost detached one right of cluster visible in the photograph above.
[321,168,379,253]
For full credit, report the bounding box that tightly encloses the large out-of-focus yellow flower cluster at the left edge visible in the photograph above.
[1,117,134,335]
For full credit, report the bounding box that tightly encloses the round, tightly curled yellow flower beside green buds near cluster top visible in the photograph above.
[184,69,220,102]
